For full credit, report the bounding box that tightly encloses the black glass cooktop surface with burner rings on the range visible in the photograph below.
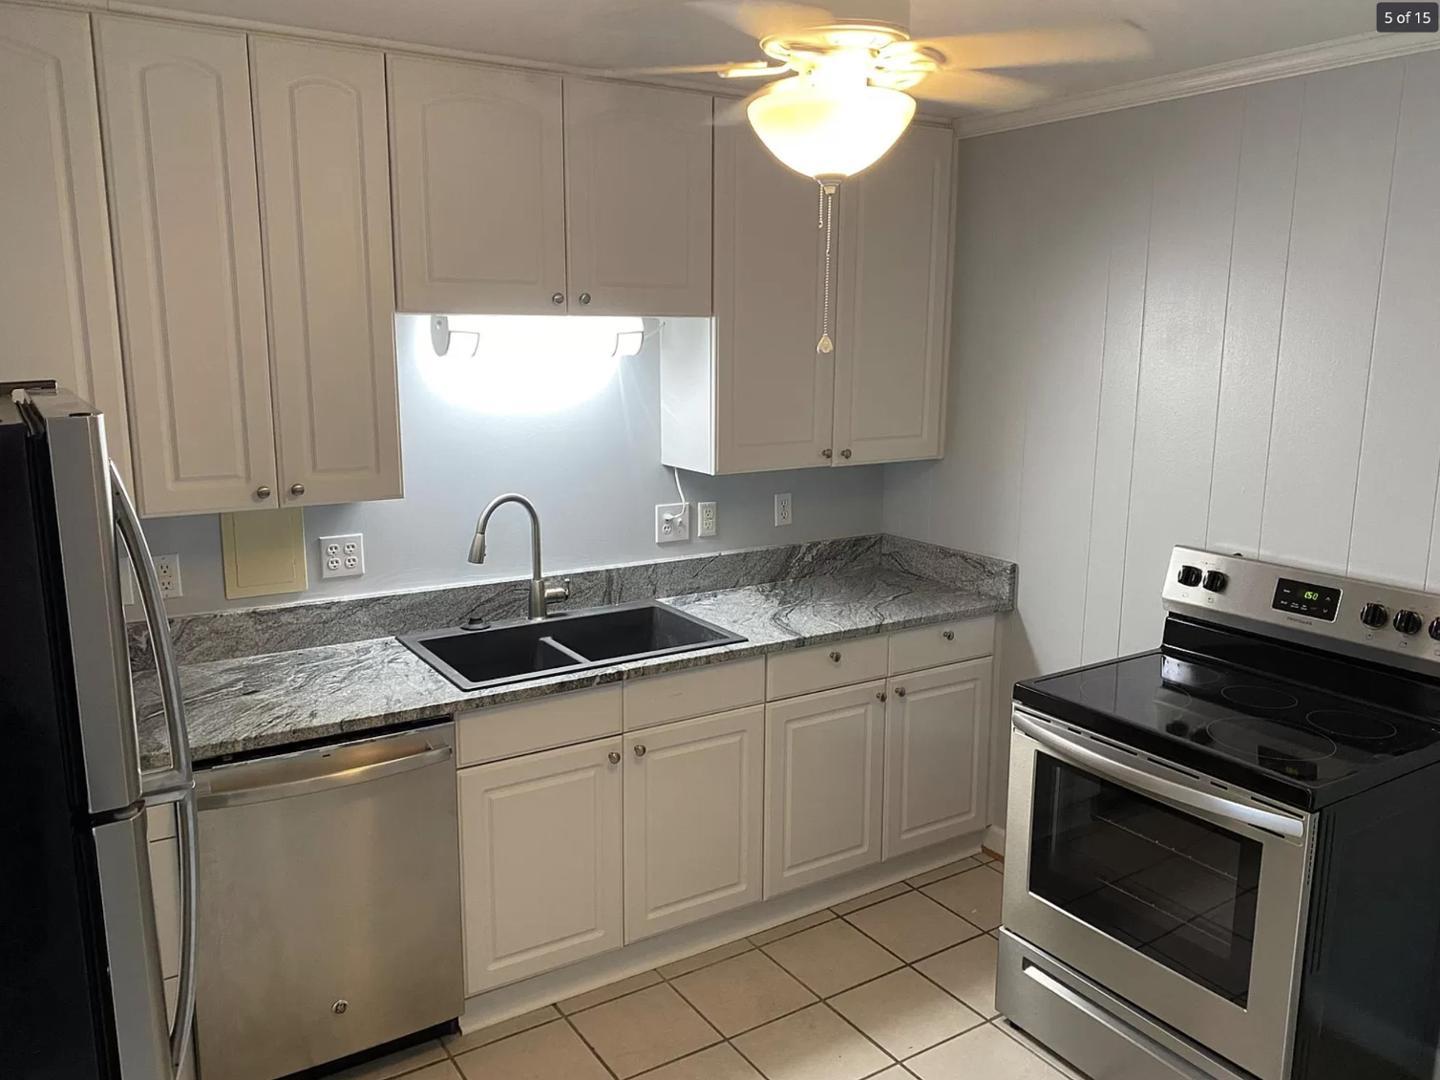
[1017,652,1440,805]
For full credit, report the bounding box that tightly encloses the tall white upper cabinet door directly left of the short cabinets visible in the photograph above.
[251,37,400,505]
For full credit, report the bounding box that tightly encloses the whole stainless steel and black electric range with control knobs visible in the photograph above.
[996,547,1440,1080]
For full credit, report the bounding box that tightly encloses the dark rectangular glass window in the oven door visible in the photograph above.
[1030,753,1261,1007]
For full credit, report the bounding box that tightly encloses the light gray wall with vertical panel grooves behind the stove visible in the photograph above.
[886,53,1440,821]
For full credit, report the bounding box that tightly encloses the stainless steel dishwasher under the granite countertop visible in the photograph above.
[196,724,465,1080]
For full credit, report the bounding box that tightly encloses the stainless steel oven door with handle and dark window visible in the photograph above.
[1004,708,1313,1080]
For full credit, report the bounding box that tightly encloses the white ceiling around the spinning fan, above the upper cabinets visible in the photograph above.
[140,0,1374,113]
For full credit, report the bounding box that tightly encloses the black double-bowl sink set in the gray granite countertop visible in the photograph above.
[397,602,744,690]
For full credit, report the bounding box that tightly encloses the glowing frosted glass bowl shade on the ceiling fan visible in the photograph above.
[746,76,914,180]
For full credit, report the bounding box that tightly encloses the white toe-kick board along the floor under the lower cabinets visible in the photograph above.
[459,829,1005,1031]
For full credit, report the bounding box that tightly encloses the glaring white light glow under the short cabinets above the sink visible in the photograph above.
[415,315,645,416]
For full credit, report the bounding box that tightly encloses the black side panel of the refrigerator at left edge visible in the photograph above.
[0,400,120,1080]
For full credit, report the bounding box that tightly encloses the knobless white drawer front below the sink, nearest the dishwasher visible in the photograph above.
[455,684,621,766]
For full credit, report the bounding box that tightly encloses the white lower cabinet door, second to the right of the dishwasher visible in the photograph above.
[625,706,765,942]
